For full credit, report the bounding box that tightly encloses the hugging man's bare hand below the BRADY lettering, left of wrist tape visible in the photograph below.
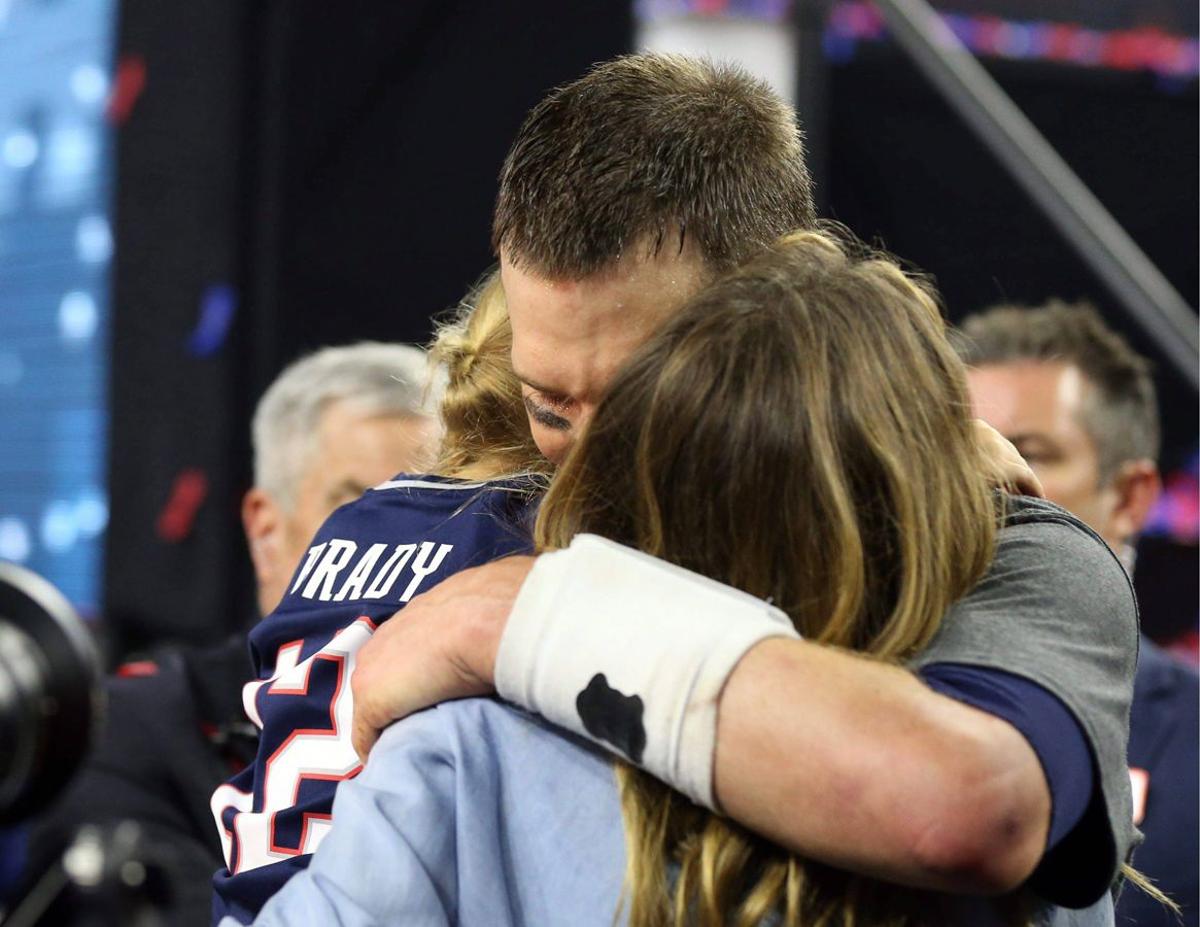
[350,557,534,762]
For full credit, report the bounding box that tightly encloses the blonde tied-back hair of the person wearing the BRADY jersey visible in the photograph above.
[430,270,550,477]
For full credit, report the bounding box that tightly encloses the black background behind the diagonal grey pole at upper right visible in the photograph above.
[826,46,1200,468]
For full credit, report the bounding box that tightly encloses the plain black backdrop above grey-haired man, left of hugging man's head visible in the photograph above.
[253,0,632,377]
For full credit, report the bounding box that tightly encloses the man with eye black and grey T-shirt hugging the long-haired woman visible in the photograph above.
[354,56,1135,923]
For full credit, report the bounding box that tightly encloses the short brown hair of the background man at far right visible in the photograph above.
[958,300,1159,484]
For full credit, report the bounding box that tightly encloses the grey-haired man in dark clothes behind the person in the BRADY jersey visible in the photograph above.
[30,342,438,925]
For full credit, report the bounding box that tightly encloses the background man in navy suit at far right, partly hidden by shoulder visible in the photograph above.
[960,301,1200,927]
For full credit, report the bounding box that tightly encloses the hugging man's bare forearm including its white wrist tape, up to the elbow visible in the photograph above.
[496,536,1050,892]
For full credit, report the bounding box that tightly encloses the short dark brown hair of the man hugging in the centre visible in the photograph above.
[492,54,816,280]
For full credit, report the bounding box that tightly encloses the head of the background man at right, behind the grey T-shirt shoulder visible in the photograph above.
[961,301,1159,550]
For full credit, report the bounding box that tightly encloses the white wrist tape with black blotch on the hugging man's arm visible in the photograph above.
[496,534,799,808]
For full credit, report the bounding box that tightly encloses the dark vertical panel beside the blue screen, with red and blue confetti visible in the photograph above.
[102,0,253,656]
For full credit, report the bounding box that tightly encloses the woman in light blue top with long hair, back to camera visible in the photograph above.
[229,232,1137,927]
